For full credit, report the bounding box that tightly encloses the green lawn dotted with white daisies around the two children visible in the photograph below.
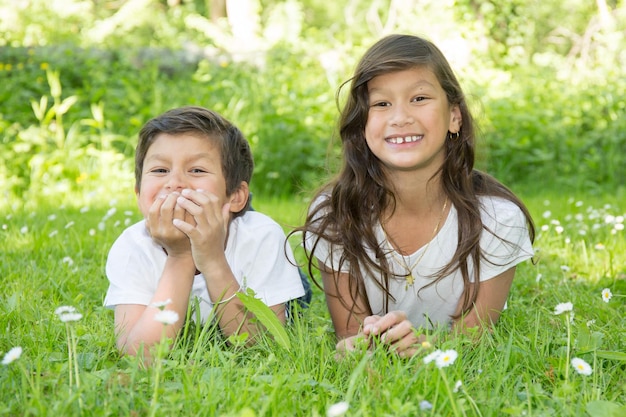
[0,187,626,416]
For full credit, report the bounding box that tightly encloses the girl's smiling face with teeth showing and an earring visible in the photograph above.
[365,67,461,177]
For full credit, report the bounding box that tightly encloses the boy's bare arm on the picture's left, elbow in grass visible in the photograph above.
[115,255,195,361]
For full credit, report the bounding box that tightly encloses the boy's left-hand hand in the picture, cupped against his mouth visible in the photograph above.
[146,192,192,257]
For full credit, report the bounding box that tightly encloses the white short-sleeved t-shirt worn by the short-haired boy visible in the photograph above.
[104,211,304,322]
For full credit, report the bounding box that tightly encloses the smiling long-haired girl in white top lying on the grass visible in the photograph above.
[299,35,535,356]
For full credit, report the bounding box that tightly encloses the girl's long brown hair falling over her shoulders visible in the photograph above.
[294,35,535,318]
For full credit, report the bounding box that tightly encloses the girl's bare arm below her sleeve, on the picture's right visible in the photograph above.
[452,267,515,332]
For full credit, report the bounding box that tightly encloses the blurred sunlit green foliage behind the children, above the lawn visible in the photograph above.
[0,0,626,201]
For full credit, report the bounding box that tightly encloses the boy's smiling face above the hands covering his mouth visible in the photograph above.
[137,133,227,217]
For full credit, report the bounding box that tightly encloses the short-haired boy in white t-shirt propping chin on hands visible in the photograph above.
[104,106,305,358]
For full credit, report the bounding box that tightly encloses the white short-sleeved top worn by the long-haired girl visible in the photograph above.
[305,197,533,328]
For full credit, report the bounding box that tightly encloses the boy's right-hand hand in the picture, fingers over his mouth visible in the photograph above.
[172,189,230,277]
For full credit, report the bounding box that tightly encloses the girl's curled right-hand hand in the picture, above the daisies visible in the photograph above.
[363,311,426,358]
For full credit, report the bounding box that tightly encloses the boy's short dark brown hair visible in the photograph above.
[135,106,254,215]
